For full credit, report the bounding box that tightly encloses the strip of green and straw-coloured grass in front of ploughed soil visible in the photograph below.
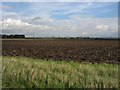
[2,57,118,88]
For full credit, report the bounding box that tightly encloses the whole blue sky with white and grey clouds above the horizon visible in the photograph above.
[0,2,118,37]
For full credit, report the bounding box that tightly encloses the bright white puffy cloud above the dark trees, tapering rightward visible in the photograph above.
[2,18,54,33]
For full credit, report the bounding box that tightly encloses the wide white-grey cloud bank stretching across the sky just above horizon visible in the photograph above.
[2,16,118,37]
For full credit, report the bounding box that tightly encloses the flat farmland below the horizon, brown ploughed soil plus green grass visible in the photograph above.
[2,39,119,88]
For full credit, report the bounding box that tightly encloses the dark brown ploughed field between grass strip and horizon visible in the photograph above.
[2,39,119,64]
